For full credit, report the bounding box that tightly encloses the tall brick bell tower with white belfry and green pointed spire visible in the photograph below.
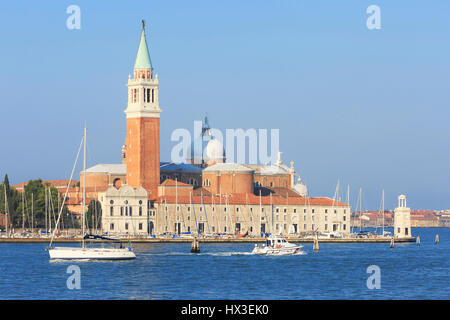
[122,20,161,199]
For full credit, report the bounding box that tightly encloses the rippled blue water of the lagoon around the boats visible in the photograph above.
[0,228,450,300]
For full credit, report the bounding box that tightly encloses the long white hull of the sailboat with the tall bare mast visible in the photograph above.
[48,247,136,260]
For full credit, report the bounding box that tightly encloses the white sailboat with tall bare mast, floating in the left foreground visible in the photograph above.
[47,127,136,260]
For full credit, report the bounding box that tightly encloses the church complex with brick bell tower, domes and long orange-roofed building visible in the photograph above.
[81,24,350,237]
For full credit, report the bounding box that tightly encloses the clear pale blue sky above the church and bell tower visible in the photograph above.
[0,0,450,210]
